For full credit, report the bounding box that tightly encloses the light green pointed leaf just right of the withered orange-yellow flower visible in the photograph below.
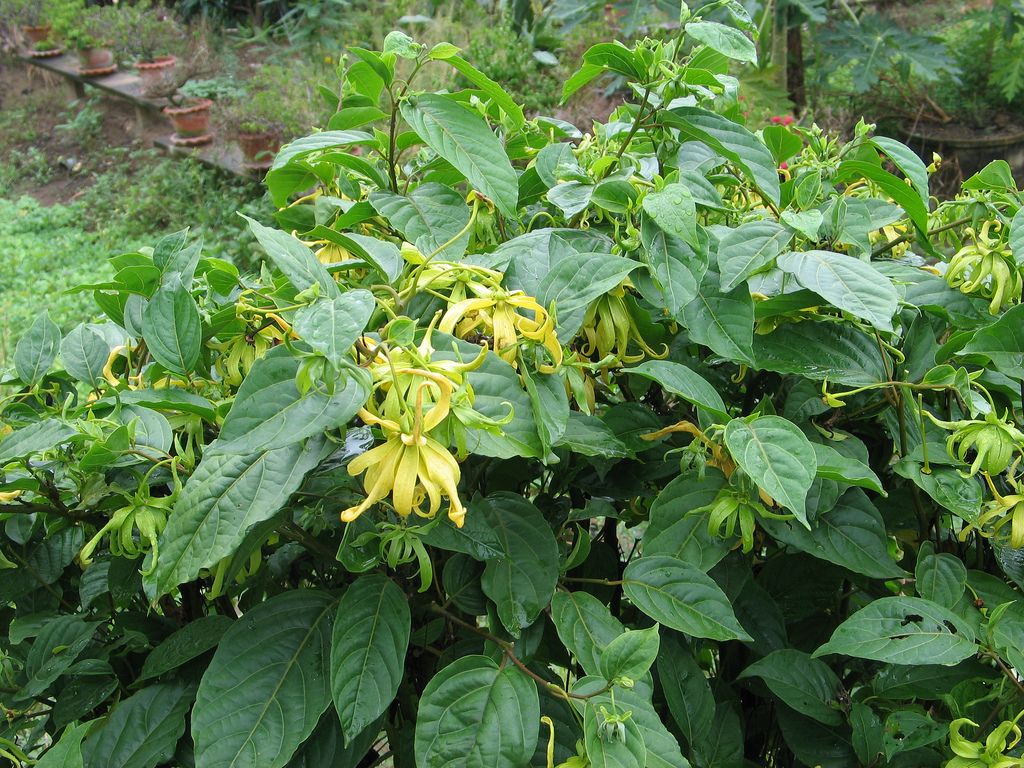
[725,416,817,525]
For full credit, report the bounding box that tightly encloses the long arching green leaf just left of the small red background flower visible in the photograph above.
[662,106,781,205]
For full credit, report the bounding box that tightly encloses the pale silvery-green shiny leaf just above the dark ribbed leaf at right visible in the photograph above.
[777,251,899,331]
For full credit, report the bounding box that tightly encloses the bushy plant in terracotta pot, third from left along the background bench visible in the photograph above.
[115,0,184,96]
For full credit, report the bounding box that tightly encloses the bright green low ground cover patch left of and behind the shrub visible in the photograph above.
[0,151,271,364]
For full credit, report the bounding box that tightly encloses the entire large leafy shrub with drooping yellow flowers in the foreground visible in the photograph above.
[6,10,1024,768]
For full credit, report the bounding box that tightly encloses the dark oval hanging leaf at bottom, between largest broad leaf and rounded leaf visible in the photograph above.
[331,573,412,744]
